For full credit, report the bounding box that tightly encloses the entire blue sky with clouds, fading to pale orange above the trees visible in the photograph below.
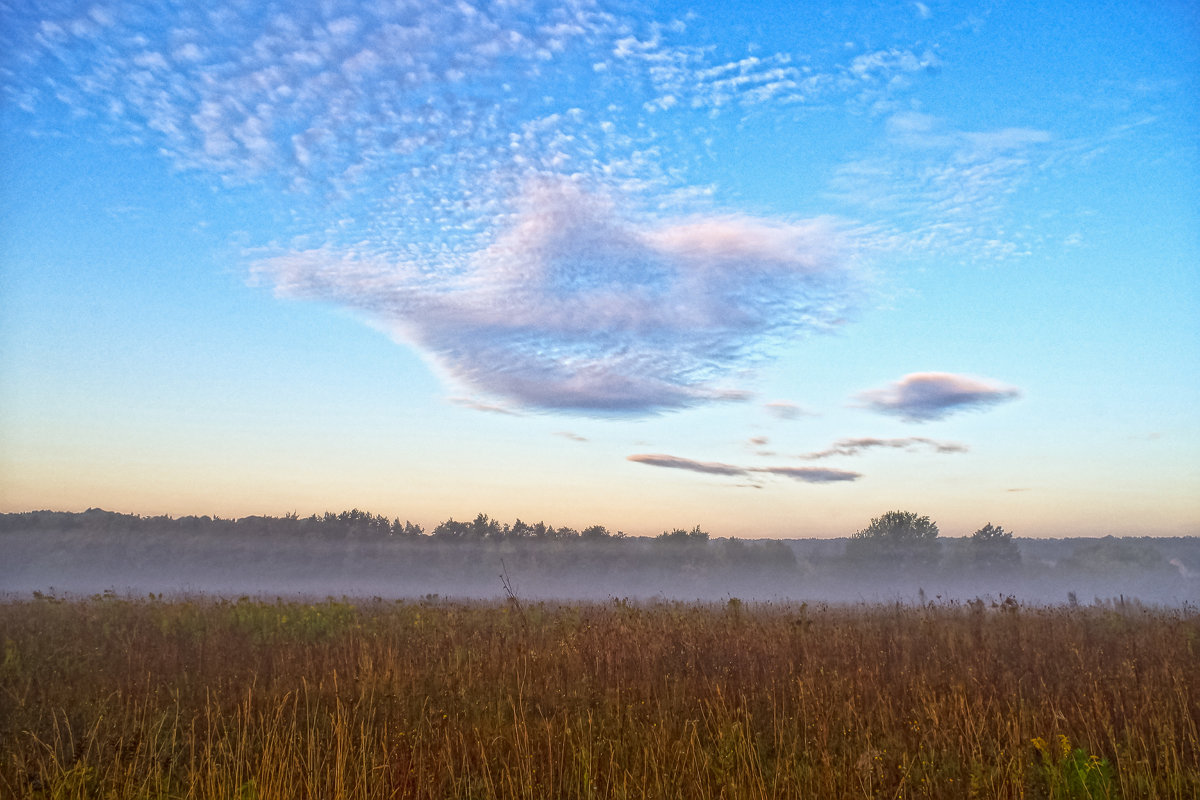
[0,0,1200,537]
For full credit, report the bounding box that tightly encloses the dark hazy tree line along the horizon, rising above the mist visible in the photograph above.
[0,509,1180,583]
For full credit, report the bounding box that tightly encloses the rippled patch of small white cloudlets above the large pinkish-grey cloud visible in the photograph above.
[0,0,936,253]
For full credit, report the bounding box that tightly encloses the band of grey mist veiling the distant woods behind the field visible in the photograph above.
[0,510,1200,607]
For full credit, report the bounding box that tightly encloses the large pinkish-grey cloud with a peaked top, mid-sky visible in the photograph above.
[256,181,854,414]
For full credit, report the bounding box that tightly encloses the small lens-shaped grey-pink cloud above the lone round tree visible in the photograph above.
[858,372,1020,422]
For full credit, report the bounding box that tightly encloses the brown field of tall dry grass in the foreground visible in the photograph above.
[0,596,1200,800]
